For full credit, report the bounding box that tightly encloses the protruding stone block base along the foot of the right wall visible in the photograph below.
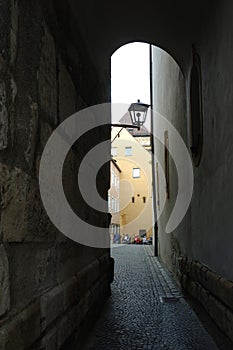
[173,249,233,341]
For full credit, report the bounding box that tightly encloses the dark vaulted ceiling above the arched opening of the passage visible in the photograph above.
[54,0,219,70]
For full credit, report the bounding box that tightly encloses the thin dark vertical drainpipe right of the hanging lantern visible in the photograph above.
[149,44,158,256]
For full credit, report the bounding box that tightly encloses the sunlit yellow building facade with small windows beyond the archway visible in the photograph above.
[112,128,153,240]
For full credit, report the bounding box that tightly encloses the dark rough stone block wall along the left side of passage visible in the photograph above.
[0,0,112,349]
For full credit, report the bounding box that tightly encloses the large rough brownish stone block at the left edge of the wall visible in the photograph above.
[0,164,55,242]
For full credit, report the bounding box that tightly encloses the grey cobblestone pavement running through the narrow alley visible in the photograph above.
[84,245,217,350]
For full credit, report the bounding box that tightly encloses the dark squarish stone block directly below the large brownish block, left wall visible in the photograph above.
[6,242,57,310]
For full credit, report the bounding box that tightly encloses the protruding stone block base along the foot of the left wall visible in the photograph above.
[0,259,110,350]
